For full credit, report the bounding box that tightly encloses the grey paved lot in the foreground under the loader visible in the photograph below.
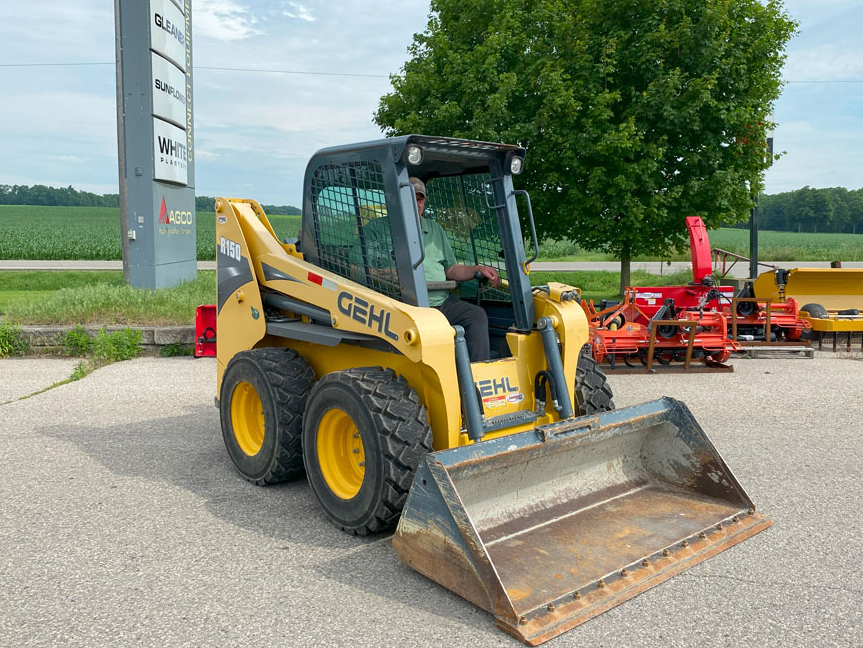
[0,358,863,648]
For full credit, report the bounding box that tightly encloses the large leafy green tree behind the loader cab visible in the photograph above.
[374,0,796,287]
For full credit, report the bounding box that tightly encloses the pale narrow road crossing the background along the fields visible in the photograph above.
[0,260,863,278]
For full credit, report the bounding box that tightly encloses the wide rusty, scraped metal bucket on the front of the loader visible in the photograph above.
[393,398,771,645]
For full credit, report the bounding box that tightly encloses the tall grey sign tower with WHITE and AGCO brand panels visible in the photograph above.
[114,0,197,289]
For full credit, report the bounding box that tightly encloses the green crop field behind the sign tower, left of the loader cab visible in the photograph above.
[0,205,300,261]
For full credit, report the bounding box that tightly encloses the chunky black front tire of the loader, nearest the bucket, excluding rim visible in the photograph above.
[303,367,433,535]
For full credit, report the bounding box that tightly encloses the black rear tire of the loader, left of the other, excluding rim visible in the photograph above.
[219,347,315,486]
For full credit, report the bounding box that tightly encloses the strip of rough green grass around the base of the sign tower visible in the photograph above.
[0,271,216,326]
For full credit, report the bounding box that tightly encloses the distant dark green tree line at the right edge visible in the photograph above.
[758,187,863,234]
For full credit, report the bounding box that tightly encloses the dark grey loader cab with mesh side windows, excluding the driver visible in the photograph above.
[301,136,534,357]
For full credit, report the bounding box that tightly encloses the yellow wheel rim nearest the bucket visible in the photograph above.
[317,409,366,500]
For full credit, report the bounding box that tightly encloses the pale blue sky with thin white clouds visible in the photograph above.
[0,0,863,206]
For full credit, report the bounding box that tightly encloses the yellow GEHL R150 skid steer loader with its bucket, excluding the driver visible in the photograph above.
[216,135,770,645]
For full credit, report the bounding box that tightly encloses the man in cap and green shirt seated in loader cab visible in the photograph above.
[410,178,500,362]
